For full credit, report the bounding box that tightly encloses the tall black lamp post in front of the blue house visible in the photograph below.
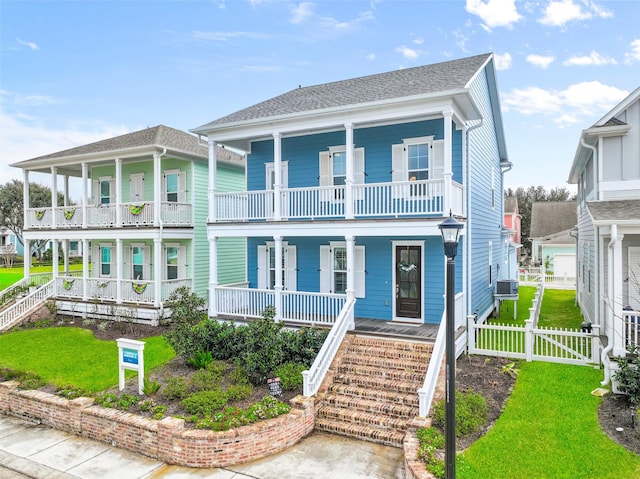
[438,212,464,479]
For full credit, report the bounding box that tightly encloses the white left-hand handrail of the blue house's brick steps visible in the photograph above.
[302,298,356,397]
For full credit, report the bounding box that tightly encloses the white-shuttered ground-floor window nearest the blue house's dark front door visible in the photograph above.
[320,241,365,298]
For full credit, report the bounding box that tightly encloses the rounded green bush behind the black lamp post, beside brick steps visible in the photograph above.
[433,389,489,437]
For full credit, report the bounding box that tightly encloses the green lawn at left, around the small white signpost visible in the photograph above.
[0,325,175,392]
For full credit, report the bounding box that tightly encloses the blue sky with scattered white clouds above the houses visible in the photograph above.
[0,0,640,193]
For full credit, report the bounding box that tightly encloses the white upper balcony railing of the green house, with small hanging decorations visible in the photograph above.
[25,201,193,229]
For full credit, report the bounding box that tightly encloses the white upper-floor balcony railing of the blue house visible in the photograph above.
[216,180,463,221]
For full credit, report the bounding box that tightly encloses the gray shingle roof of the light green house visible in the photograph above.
[12,125,208,167]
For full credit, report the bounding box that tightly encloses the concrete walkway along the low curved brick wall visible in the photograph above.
[0,414,404,479]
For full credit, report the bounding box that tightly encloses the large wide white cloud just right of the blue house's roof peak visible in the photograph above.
[502,81,629,127]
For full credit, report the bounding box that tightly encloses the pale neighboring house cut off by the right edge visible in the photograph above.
[569,84,640,386]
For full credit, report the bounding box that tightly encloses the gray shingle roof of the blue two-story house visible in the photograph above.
[193,53,491,131]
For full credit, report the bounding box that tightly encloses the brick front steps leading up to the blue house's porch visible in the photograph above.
[315,335,433,447]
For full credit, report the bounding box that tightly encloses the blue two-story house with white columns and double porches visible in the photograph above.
[192,54,511,344]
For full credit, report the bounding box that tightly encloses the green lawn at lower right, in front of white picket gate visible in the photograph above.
[457,362,640,479]
